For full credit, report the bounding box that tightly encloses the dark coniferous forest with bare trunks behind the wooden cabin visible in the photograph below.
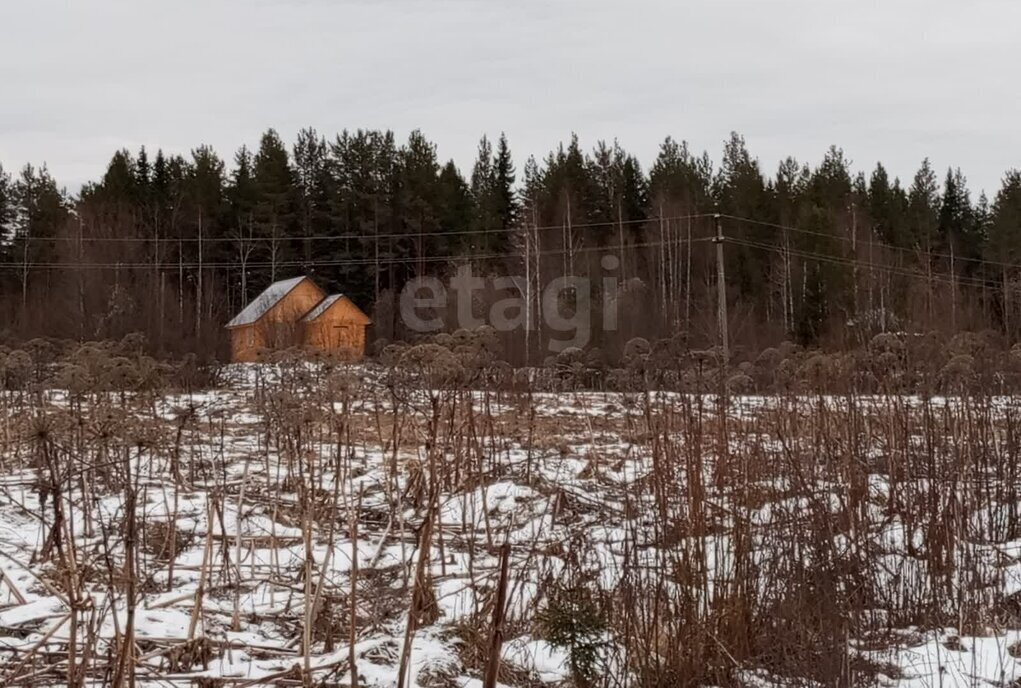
[0,129,1021,363]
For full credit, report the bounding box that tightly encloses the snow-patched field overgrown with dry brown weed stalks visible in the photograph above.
[0,364,1021,688]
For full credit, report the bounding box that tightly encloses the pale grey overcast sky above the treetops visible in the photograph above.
[0,0,1021,196]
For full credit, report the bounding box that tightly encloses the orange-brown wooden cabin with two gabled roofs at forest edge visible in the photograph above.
[227,277,372,362]
